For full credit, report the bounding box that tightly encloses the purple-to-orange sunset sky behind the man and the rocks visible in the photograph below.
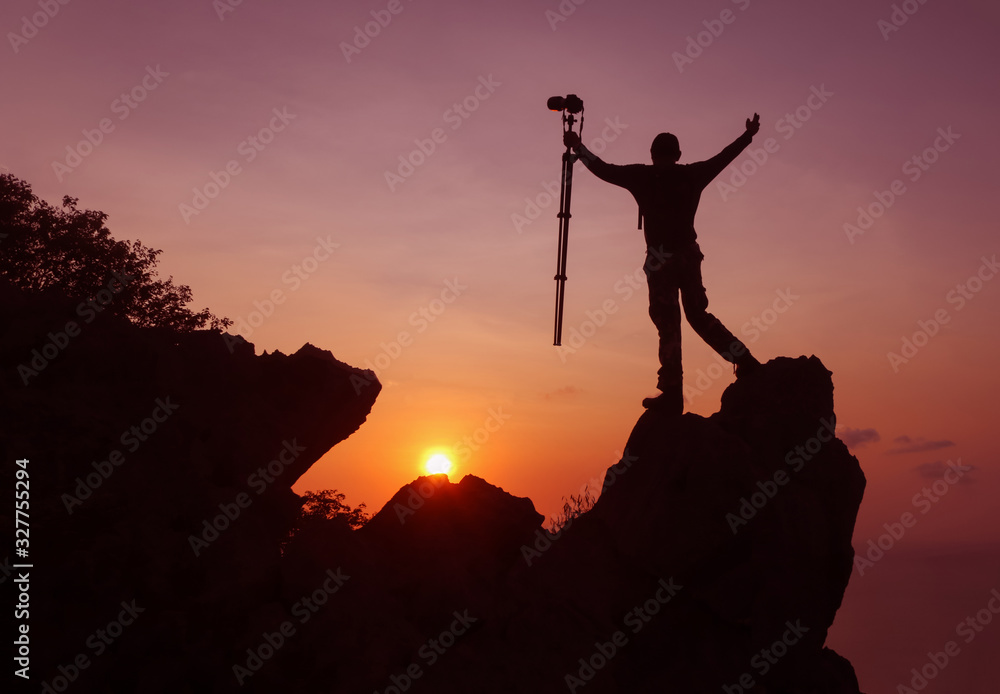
[0,0,1000,693]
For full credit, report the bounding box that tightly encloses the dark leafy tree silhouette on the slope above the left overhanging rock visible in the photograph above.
[0,174,232,332]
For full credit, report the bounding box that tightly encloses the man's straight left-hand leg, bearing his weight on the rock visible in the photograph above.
[644,256,684,414]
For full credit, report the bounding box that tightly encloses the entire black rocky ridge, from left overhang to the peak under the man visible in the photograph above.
[0,280,865,694]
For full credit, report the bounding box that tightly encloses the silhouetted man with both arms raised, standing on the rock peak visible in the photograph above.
[565,113,760,414]
